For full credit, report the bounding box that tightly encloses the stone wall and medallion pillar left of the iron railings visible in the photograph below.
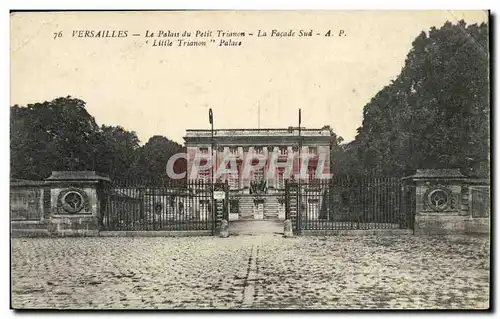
[10,171,109,236]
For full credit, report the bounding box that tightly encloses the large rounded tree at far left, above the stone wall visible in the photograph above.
[10,96,99,180]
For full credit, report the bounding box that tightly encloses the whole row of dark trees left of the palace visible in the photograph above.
[10,96,186,182]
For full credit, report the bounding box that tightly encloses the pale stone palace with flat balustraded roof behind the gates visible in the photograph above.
[184,126,332,219]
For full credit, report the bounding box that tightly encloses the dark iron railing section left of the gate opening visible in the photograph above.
[102,180,214,230]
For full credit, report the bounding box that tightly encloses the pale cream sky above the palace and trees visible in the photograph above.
[10,11,488,143]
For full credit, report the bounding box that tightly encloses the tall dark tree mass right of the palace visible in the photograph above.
[344,21,490,175]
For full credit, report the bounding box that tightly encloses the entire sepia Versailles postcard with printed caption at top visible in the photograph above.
[10,10,491,310]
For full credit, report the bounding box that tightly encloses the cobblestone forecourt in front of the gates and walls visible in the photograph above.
[11,235,489,309]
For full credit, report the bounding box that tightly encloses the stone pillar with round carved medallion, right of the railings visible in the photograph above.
[412,169,472,235]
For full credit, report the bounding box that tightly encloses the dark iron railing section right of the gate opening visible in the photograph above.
[286,176,415,230]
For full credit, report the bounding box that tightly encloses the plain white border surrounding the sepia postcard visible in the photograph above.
[0,0,499,318]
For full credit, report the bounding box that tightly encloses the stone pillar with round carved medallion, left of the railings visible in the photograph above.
[46,171,111,236]
